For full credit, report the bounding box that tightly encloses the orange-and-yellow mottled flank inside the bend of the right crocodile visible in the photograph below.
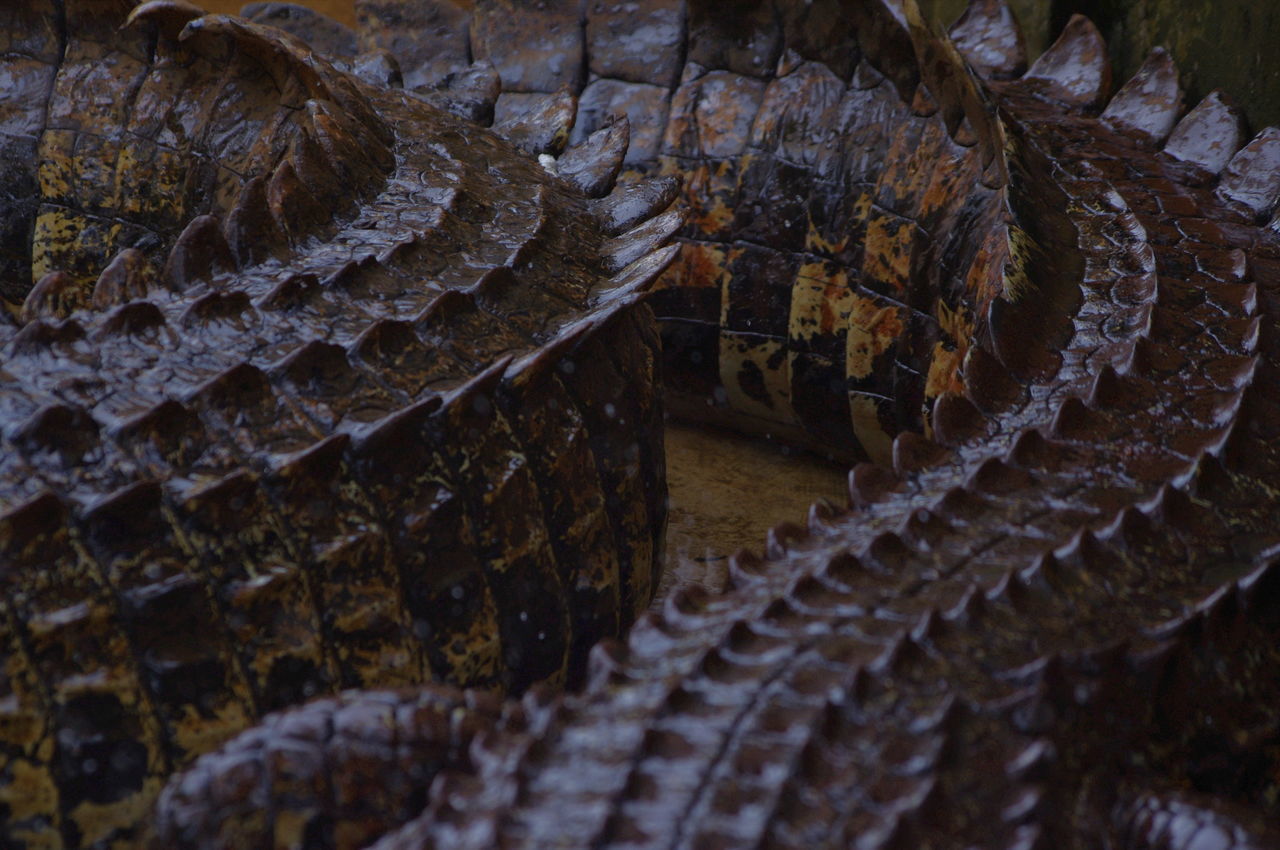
[658,52,1000,460]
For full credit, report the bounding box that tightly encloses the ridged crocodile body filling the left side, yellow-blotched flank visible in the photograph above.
[0,0,678,847]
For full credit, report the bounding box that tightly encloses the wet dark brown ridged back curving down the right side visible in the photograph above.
[312,3,1280,849]
